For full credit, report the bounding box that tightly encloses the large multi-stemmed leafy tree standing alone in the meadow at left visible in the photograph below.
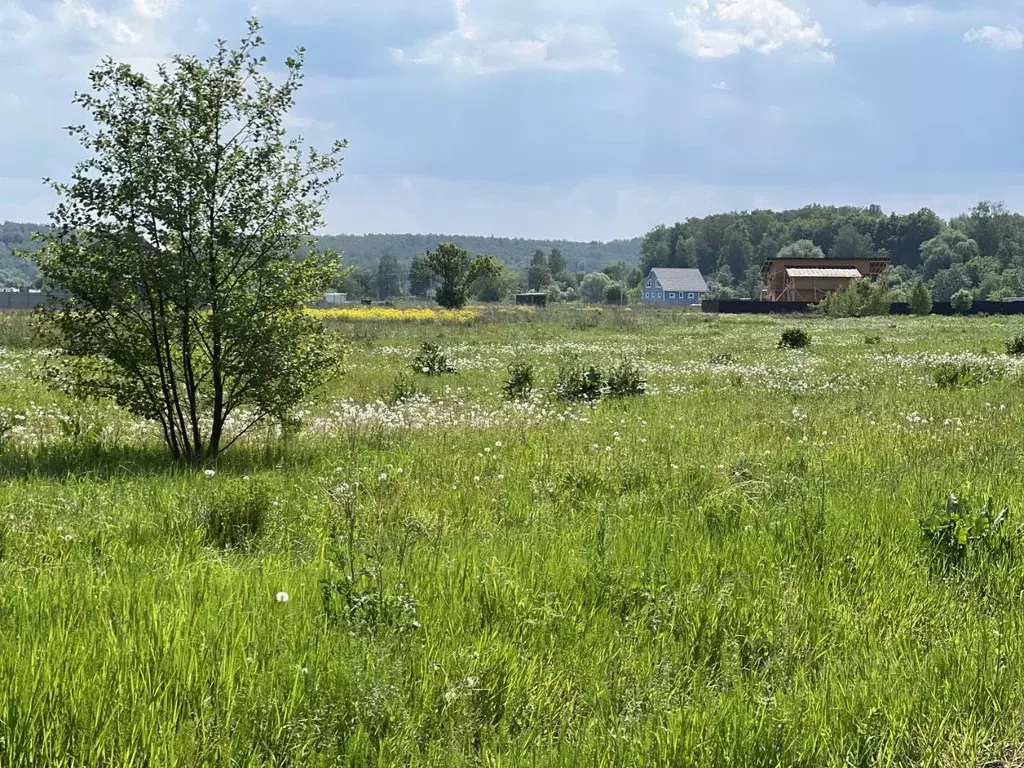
[39,19,345,464]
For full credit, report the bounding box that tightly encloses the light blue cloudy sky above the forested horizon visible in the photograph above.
[0,0,1024,241]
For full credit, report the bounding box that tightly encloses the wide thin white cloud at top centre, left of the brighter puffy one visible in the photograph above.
[391,0,620,77]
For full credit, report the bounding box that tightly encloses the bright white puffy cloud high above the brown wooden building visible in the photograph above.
[672,0,833,60]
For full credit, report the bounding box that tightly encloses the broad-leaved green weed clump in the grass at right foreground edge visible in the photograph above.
[920,494,1013,570]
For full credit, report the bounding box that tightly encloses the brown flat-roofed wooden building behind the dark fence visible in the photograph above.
[761,259,889,303]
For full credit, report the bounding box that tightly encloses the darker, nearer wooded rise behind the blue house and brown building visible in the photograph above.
[640,202,1024,301]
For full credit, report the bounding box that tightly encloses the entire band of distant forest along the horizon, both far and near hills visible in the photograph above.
[6,202,1024,302]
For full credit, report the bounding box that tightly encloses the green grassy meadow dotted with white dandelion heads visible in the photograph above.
[0,310,1024,768]
